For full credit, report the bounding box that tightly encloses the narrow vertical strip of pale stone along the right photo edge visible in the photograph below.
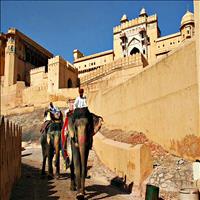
[194,0,200,136]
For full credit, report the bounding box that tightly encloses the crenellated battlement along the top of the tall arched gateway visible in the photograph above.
[113,14,157,33]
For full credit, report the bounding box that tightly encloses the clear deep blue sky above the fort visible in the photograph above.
[1,0,193,62]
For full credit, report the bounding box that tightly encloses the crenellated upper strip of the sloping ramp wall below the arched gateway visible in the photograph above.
[80,53,148,84]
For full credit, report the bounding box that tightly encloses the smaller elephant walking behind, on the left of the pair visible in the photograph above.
[40,108,63,178]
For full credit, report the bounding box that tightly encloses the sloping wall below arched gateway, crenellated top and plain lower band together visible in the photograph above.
[80,54,147,93]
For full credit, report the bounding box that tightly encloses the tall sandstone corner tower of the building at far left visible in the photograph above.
[4,37,17,86]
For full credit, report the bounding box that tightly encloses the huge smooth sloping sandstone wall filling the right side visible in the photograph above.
[88,40,200,158]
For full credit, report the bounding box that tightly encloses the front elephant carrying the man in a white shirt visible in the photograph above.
[68,111,103,200]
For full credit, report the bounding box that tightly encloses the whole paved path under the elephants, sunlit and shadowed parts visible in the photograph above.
[11,147,132,200]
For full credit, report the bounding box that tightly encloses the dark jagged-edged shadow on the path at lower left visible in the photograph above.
[10,164,60,200]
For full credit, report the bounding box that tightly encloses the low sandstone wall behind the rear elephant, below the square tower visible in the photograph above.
[1,81,79,111]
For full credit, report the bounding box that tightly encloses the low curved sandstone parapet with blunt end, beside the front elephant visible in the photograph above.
[94,133,153,186]
